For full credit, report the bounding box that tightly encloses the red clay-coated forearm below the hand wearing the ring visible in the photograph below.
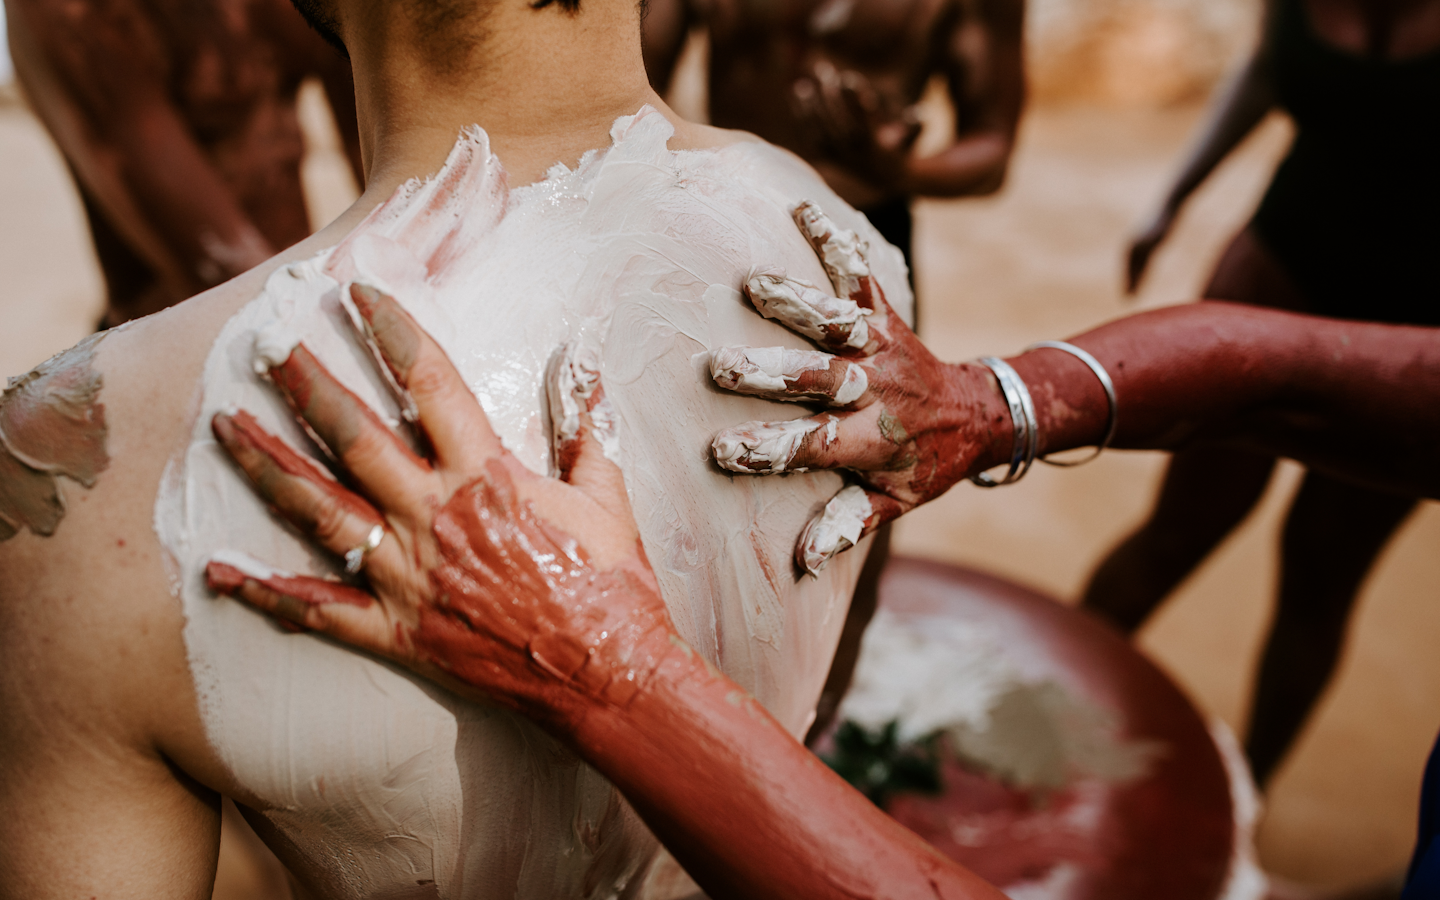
[570,642,1002,900]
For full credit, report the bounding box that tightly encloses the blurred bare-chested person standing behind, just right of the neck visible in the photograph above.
[645,0,1025,308]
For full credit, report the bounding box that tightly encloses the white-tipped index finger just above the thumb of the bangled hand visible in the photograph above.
[711,403,909,475]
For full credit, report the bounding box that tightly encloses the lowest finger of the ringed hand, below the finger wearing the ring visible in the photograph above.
[204,552,395,655]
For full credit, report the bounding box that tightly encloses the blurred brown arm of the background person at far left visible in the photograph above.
[7,0,269,289]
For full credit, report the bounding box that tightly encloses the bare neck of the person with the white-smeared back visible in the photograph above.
[344,0,680,201]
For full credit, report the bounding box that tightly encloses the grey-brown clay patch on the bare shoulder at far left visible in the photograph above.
[0,334,109,540]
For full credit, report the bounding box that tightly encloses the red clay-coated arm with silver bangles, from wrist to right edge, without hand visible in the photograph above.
[1009,301,1440,497]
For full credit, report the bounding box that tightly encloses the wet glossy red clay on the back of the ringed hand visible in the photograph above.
[410,461,672,716]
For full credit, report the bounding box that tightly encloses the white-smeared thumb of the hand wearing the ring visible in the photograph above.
[546,341,631,517]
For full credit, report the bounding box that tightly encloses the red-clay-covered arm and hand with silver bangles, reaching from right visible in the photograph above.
[711,203,1440,564]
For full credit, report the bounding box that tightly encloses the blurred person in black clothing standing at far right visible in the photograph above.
[1084,0,1440,785]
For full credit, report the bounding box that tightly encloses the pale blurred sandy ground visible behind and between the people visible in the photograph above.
[0,86,1440,884]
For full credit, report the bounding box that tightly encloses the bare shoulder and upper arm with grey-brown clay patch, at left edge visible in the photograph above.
[0,329,227,900]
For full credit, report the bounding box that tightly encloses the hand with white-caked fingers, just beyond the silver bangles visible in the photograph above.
[710,202,1011,575]
